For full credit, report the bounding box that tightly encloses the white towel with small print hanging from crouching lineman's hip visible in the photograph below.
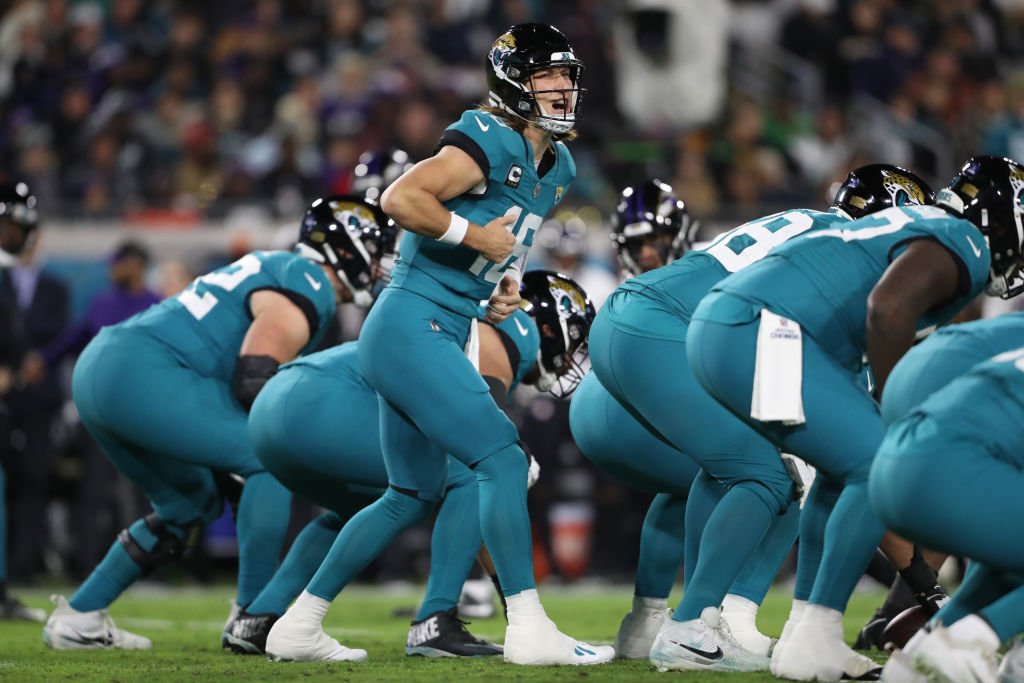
[751,308,805,425]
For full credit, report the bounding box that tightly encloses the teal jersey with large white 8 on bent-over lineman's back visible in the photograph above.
[608,209,850,339]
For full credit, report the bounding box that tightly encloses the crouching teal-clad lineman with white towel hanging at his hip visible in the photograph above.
[687,157,1024,681]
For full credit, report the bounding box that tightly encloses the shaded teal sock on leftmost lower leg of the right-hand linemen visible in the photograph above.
[634,494,686,599]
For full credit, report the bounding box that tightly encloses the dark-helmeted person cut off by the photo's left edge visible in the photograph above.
[0,182,46,622]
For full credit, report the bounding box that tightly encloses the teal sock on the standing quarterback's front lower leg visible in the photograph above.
[473,443,536,593]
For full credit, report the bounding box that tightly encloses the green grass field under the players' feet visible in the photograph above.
[0,586,884,683]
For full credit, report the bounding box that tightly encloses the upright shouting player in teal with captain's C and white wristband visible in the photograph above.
[275,24,613,665]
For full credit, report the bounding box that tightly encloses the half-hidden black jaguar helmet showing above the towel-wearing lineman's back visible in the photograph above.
[830,164,935,219]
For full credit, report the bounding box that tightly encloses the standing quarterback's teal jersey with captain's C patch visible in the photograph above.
[391,110,575,317]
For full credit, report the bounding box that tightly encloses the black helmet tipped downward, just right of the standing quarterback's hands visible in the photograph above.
[519,270,597,398]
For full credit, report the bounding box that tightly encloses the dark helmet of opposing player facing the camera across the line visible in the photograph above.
[611,180,698,275]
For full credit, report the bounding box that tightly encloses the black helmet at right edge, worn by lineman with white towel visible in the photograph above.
[935,156,1024,299]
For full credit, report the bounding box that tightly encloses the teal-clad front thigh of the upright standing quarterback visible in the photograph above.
[358,290,518,465]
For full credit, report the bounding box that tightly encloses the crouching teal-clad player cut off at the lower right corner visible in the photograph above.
[869,344,1024,681]
